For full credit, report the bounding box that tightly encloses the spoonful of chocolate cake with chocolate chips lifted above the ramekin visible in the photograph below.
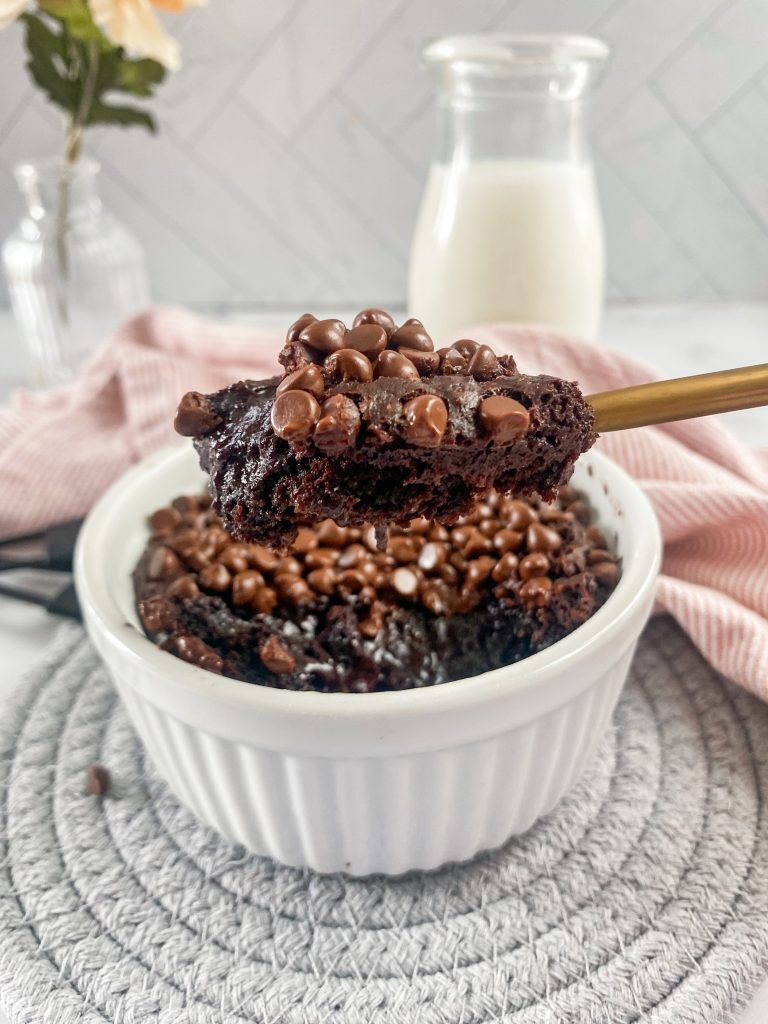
[176,309,596,548]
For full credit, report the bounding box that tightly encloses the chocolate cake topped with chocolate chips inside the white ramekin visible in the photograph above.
[134,483,618,692]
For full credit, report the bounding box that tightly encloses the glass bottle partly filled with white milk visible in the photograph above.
[409,35,608,339]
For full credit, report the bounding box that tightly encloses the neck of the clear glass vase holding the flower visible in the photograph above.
[14,159,101,222]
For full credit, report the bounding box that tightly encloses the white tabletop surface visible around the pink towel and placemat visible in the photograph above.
[0,303,768,1024]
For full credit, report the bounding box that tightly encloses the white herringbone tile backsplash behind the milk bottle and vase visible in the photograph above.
[0,0,768,307]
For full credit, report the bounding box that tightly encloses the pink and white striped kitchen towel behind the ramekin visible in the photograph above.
[0,308,768,699]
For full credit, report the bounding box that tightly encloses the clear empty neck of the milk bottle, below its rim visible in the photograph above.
[436,92,591,165]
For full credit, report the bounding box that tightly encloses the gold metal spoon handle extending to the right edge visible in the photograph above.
[587,362,768,433]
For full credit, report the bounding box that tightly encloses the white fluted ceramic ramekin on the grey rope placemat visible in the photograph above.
[76,447,662,874]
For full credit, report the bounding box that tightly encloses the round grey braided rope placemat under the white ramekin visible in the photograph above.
[0,618,768,1024]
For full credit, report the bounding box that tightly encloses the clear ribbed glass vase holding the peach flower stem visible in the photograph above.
[2,159,150,387]
